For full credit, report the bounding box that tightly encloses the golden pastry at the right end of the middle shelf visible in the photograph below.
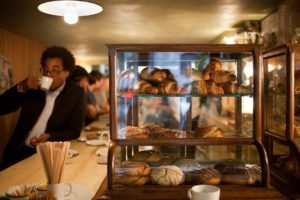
[195,126,224,138]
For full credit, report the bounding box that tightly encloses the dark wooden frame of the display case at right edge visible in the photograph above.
[263,45,300,199]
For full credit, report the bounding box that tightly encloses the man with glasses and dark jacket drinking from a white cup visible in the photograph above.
[0,46,85,169]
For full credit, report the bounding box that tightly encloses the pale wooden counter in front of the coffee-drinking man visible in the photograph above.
[0,136,107,196]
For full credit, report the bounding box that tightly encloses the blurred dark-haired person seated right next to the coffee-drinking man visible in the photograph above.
[69,65,100,125]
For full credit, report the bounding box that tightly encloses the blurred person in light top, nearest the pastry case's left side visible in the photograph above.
[90,70,109,114]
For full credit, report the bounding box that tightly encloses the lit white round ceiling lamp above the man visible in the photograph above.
[38,0,103,24]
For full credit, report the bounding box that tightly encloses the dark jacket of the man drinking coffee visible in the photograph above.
[0,81,85,157]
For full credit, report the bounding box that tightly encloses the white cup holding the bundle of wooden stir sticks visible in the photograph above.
[48,183,72,200]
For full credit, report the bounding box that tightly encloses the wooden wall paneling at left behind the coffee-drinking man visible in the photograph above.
[0,29,46,160]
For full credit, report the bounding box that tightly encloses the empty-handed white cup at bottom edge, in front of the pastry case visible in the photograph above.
[188,185,220,200]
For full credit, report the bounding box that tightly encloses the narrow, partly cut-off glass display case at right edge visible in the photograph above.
[263,45,300,198]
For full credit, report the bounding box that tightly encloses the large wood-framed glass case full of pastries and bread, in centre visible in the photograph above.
[108,44,269,197]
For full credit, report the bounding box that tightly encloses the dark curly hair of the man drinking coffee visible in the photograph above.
[40,46,75,72]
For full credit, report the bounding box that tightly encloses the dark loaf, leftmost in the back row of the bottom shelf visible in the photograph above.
[131,150,163,164]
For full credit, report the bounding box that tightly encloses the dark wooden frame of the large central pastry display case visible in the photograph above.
[108,44,270,196]
